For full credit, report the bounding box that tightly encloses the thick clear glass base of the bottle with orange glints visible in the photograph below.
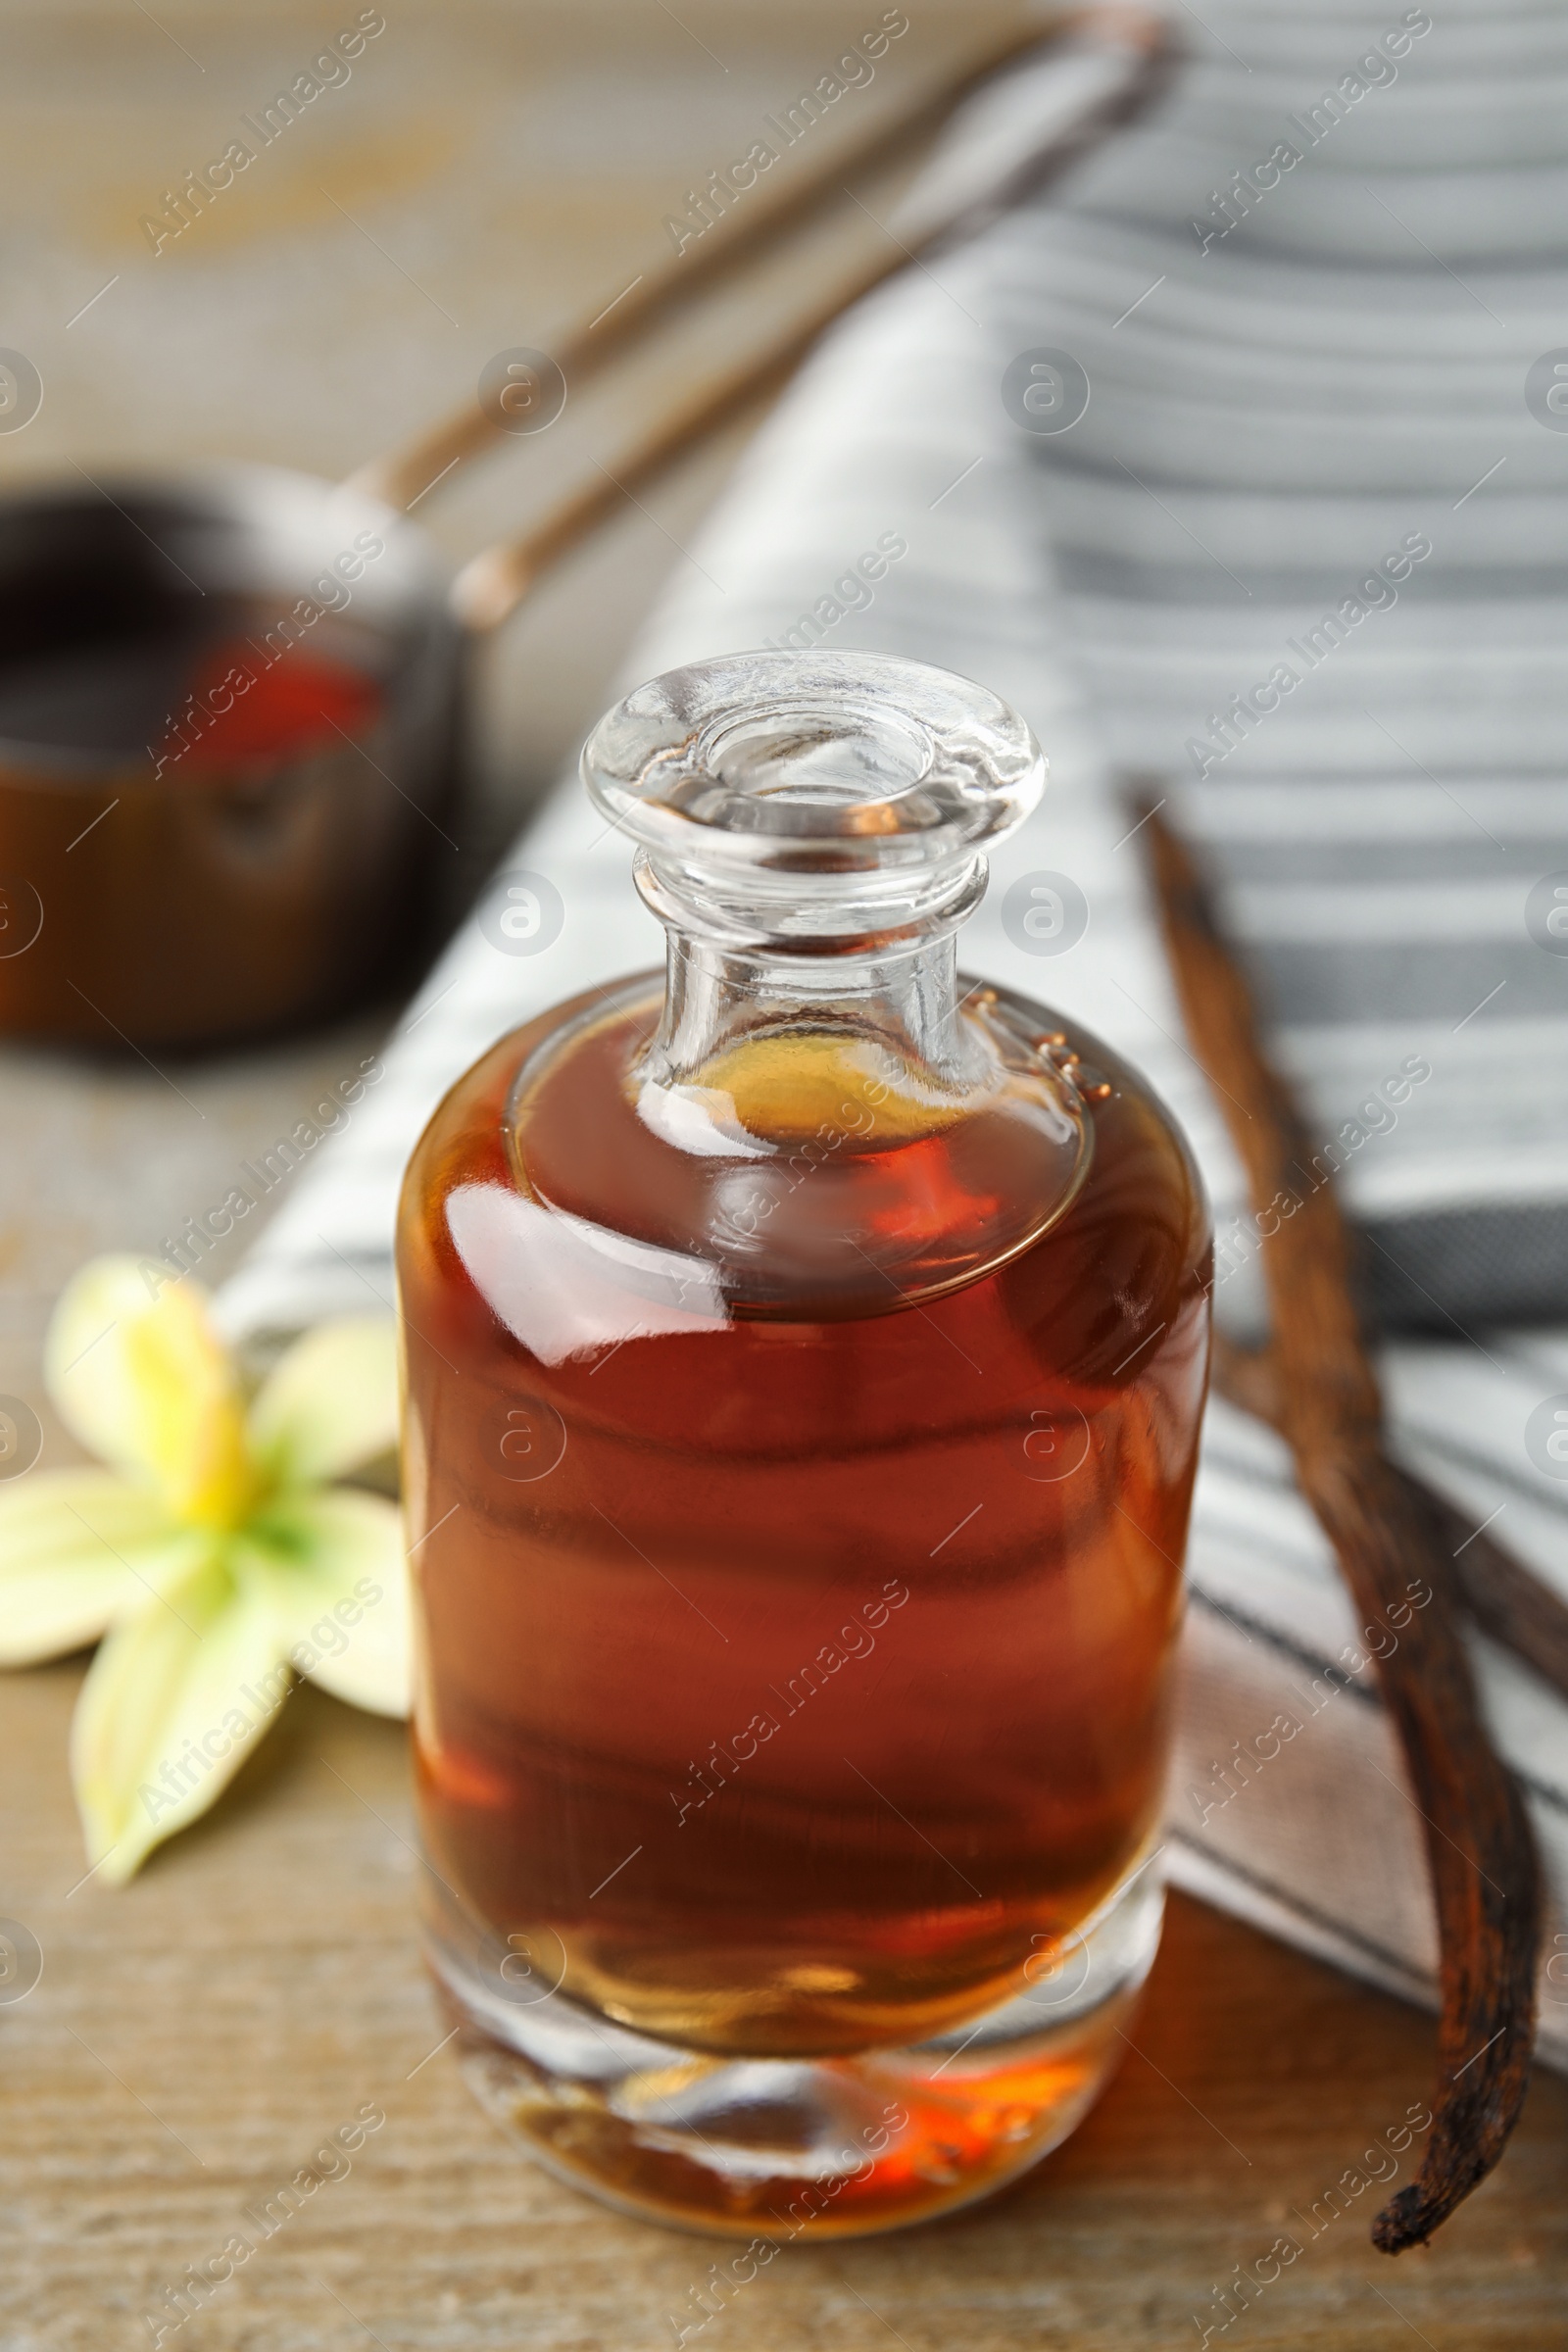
[428,1863,1163,2244]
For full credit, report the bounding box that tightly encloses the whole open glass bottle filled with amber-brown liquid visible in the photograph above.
[400,652,1210,2244]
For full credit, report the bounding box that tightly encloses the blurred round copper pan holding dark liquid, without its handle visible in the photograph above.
[0,466,464,1047]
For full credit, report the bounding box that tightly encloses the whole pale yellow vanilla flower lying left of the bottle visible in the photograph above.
[0,1256,409,1884]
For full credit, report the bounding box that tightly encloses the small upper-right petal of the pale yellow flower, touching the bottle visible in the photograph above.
[252,1315,397,1487]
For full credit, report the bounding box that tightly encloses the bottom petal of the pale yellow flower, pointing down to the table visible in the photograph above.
[71,1547,291,1886]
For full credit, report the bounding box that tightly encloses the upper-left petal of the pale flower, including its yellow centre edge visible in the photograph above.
[45,1256,254,1527]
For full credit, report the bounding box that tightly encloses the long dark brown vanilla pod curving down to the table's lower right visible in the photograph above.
[1138,807,1540,2253]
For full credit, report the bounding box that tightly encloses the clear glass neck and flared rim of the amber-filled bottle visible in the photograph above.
[583,647,1046,1115]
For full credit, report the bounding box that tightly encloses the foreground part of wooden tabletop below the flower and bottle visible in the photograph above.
[0,1663,1568,2352]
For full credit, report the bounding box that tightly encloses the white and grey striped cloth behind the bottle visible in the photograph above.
[223,0,1568,2063]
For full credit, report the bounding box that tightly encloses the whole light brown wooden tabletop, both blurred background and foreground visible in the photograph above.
[0,0,1568,2352]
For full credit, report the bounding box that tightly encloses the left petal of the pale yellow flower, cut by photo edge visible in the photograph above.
[0,1470,207,1665]
